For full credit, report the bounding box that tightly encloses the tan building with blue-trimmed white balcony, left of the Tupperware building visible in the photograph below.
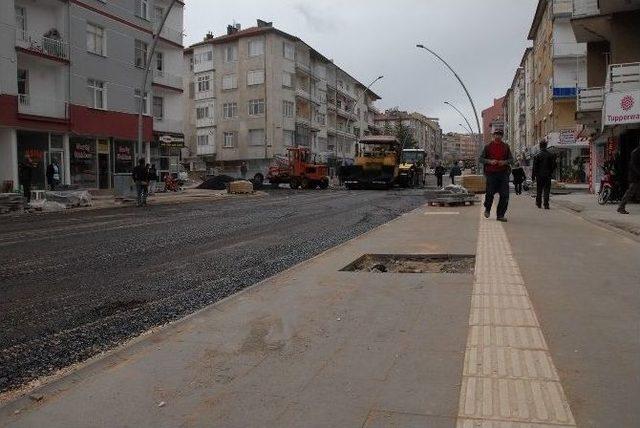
[528,0,588,177]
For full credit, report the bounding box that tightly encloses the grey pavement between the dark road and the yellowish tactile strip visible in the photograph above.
[0,202,479,427]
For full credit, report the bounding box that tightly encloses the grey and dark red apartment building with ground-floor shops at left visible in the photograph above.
[0,0,183,189]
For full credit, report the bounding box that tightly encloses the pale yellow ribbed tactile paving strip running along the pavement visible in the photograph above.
[457,212,576,428]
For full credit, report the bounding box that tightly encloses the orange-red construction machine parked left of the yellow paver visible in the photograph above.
[267,147,329,189]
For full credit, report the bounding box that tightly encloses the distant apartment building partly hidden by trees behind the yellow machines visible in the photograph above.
[374,108,442,164]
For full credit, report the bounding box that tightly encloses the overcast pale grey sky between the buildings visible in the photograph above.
[184,0,537,132]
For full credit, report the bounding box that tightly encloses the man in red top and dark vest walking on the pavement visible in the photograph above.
[480,129,513,221]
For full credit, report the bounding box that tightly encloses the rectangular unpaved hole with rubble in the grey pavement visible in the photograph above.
[340,254,476,274]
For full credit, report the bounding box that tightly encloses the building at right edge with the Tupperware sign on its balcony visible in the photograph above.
[571,0,640,191]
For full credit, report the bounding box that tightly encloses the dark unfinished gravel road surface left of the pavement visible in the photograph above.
[0,189,425,392]
